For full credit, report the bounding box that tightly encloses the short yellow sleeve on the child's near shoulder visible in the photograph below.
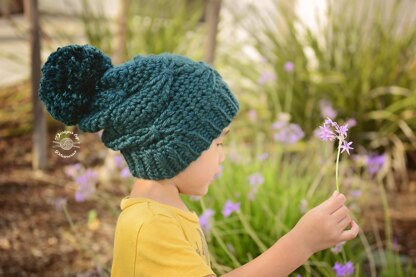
[134,214,216,277]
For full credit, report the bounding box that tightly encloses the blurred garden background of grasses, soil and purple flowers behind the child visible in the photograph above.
[0,0,416,276]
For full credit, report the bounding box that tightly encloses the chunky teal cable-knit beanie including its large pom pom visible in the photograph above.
[39,44,239,180]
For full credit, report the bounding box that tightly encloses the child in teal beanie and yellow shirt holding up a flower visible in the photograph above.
[39,45,358,277]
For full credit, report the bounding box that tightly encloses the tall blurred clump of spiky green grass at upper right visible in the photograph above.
[226,1,416,154]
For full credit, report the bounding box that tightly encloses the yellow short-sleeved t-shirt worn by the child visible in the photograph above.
[111,196,216,277]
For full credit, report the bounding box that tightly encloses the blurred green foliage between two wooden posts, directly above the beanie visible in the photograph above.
[128,0,204,56]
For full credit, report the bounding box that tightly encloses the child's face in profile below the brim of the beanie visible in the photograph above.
[174,126,230,196]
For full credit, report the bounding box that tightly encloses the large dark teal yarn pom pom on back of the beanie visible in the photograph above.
[39,44,113,125]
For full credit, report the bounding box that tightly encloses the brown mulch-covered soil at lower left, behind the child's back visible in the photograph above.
[0,129,123,276]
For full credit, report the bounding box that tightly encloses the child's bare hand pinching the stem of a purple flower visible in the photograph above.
[292,191,359,253]
